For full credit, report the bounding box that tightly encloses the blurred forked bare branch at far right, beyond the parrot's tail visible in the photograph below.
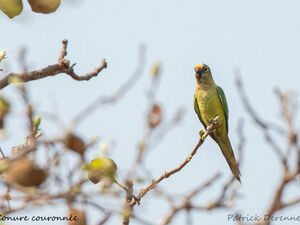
[236,71,300,225]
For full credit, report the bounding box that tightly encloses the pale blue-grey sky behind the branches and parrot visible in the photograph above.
[0,0,300,225]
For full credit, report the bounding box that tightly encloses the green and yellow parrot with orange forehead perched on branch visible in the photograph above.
[194,64,241,182]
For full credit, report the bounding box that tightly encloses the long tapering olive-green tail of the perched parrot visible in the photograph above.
[218,135,241,183]
